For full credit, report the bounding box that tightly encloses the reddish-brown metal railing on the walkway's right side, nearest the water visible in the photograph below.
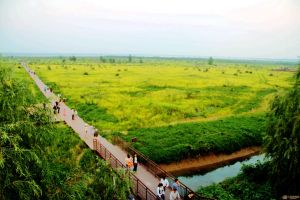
[113,137,215,200]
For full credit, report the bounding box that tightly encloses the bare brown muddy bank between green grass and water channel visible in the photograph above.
[160,147,261,175]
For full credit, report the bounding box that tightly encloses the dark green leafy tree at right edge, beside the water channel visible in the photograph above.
[264,64,300,195]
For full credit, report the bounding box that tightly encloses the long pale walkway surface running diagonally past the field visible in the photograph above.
[21,62,169,199]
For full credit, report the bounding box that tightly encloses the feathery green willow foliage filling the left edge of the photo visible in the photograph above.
[0,66,51,199]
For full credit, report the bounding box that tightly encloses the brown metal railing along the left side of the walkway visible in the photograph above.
[93,139,157,200]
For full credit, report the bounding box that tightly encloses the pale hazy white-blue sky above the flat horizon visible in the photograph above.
[0,0,300,58]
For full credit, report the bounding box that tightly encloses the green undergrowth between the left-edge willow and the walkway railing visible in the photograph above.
[40,124,130,199]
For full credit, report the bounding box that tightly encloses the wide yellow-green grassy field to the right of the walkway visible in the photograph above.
[24,59,293,162]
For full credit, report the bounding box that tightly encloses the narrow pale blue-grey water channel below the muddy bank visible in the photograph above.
[178,154,265,191]
